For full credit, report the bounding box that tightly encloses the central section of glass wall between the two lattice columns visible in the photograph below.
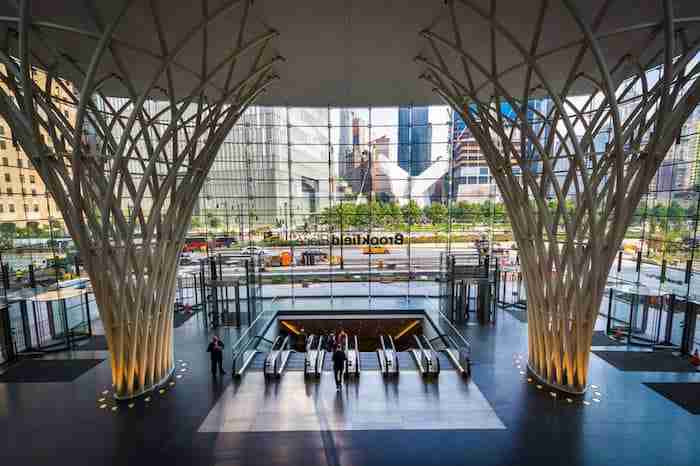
[190,106,482,307]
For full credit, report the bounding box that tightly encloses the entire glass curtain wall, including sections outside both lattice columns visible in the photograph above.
[0,93,700,346]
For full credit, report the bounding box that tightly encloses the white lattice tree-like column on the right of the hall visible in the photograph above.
[416,0,700,393]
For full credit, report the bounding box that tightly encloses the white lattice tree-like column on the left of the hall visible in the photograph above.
[0,0,280,398]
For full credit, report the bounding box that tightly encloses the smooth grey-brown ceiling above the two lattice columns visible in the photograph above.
[0,0,700,106]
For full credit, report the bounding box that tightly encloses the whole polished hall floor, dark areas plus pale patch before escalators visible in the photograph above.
[0,303,700,466]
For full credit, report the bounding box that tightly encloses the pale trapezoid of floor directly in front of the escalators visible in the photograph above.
[199,371,505,432]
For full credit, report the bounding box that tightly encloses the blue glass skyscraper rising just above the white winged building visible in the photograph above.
[398,107,432,176]
